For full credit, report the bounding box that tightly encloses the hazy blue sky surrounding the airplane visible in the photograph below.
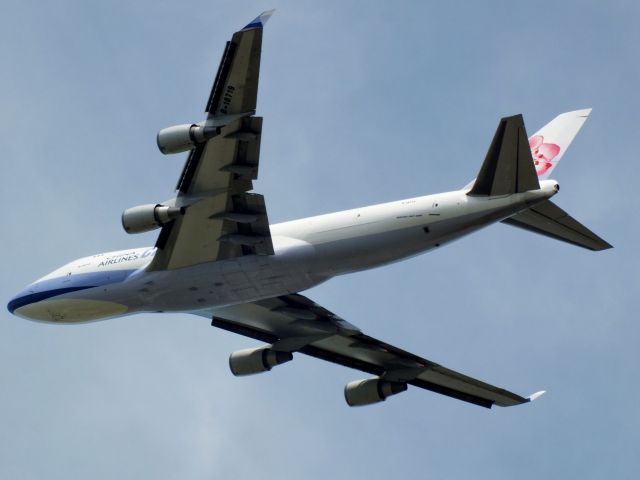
[0,0,640,480]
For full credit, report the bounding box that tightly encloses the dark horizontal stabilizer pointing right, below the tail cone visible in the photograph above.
[502,200,612,251]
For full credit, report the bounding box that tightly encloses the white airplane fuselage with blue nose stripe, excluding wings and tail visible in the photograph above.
[8,180,557,322]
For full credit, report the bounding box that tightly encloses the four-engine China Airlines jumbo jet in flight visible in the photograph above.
[8,11,611,408]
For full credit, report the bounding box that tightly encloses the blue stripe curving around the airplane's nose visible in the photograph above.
[7,270,136,313]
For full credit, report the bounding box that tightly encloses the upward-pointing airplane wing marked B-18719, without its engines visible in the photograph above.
[149,12,273,270]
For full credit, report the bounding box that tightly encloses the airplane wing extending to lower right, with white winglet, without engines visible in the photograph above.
[193,294,541,408]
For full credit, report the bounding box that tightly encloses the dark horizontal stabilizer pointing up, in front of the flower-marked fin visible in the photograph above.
[468,115,540,196]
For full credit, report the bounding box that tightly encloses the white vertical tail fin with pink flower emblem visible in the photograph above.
[529,108,591,180]
